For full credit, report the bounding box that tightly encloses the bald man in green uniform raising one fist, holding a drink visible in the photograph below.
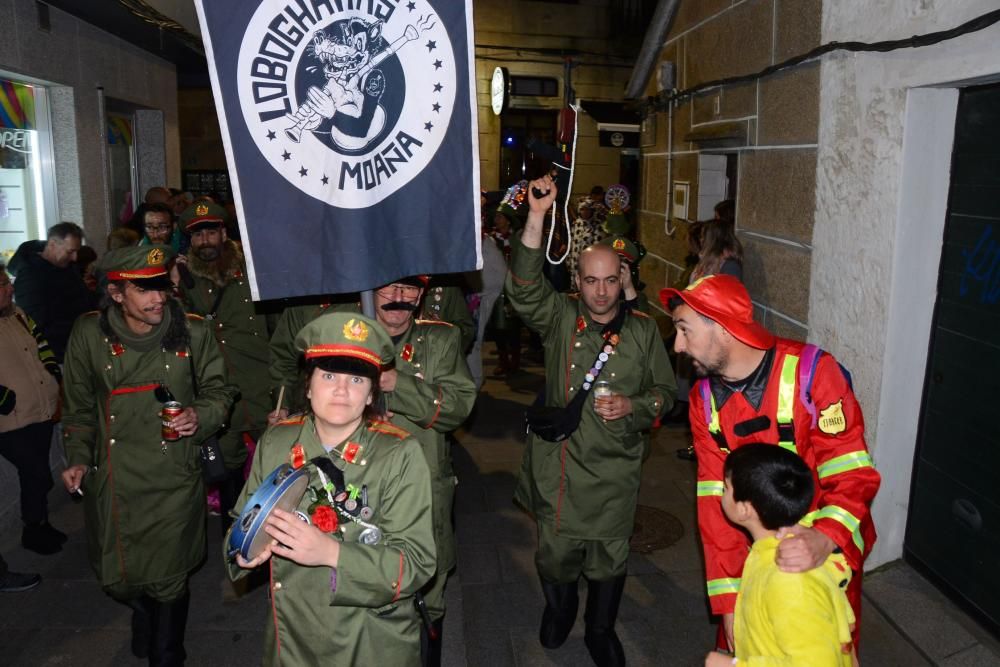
[506,176,677,666]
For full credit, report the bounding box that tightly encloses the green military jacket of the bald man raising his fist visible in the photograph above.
[505,238,677,540]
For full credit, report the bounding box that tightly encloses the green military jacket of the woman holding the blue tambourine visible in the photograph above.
[229,417,434,667]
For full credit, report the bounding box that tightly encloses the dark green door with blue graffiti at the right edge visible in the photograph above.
[905,85,1000,628]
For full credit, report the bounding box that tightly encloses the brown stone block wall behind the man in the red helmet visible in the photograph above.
[640,0,822,339]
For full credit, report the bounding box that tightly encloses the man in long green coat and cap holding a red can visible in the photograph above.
[62,246,235,665]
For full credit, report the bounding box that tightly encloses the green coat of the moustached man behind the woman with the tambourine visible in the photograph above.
[271,304,476,572]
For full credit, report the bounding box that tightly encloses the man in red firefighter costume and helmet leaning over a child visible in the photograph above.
[660,275,880,648]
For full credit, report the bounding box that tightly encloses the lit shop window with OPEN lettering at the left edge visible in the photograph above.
[0,73,56,263]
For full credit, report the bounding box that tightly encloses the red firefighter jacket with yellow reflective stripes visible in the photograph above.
[690,338,880,614]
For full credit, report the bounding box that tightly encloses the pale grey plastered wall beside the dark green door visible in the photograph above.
[808,0,1000,567]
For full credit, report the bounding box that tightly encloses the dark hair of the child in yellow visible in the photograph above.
[723,443,813,530]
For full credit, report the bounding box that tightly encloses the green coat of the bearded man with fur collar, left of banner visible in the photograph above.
[180,241,274,468]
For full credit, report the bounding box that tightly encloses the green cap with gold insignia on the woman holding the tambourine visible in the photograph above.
[295,313,395,378]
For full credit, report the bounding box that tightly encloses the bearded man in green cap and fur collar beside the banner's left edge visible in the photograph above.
[178,202,271,534]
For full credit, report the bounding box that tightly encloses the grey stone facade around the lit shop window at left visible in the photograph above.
[0,0,180,250]
